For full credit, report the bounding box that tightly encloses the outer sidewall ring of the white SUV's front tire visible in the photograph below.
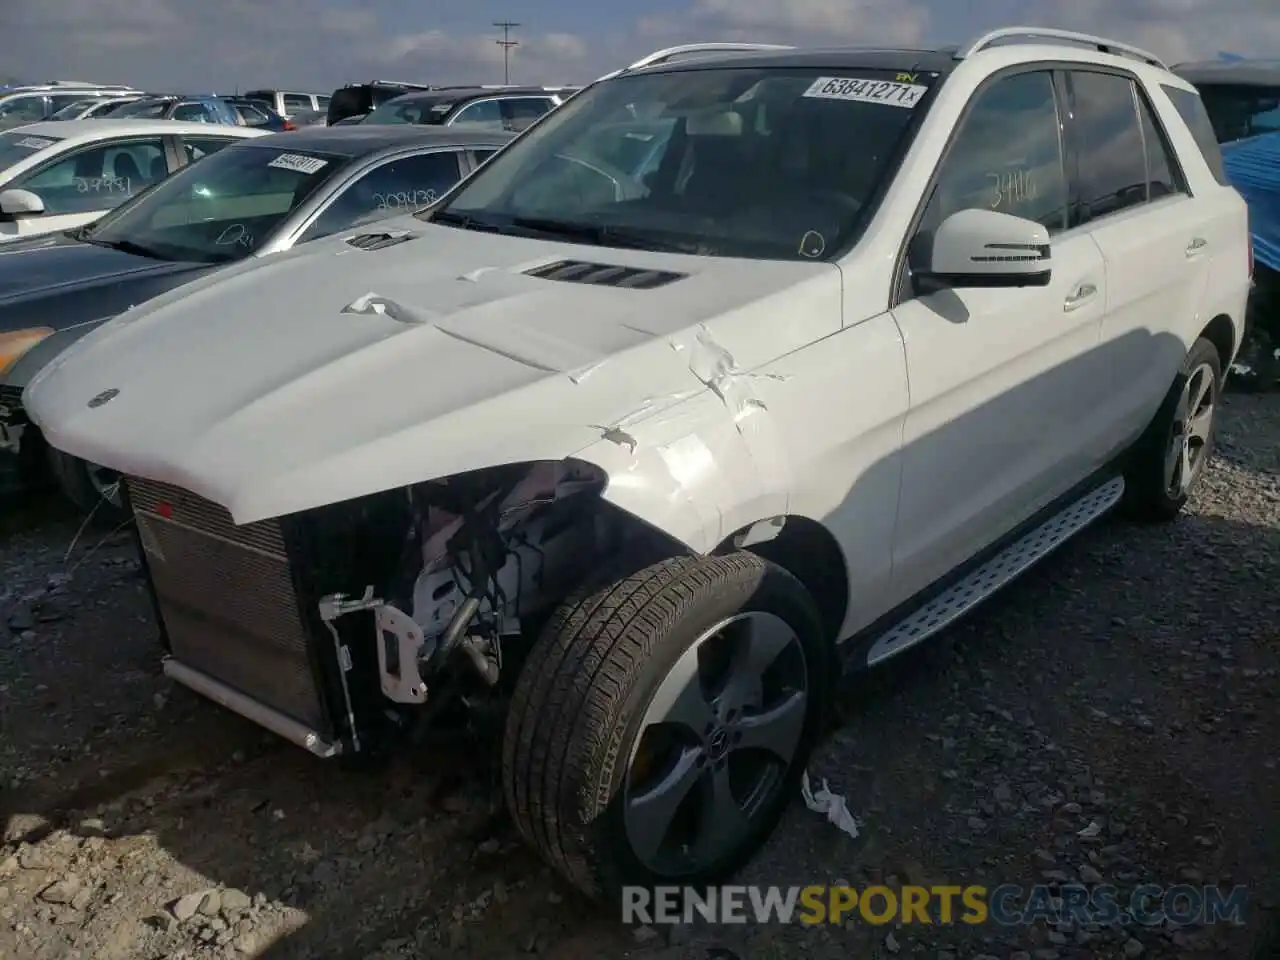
[595,561,836,902]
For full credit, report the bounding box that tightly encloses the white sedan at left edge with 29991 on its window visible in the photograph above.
[0,119,266,246]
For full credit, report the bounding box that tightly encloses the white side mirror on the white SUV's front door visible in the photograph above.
[915,210,1053,288]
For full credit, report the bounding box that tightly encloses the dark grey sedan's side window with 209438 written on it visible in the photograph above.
[298,151,462,243]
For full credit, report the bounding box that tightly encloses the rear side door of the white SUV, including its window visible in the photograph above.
[1066,69,1213,453]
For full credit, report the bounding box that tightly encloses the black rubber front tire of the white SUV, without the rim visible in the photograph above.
[502,553,835,902]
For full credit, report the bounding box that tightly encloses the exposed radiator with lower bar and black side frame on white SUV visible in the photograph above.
[123,477,399,758]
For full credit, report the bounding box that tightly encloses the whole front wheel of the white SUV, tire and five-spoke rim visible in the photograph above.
[503,553,833,901]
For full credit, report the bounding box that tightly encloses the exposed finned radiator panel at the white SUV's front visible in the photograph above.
[125,477,329,731]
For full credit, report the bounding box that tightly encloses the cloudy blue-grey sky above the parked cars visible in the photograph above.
[0,0,1280,92]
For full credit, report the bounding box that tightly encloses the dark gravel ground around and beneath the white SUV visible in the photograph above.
[0,396,1280,960]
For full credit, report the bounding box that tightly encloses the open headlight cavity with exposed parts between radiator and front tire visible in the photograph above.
[315,461,680,732]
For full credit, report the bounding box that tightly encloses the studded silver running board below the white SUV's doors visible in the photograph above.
[867,476,1124,667]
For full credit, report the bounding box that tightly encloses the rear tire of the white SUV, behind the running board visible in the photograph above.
[1124,338,1222,522]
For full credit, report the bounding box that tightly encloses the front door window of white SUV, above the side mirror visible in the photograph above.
[920,72,1064,240]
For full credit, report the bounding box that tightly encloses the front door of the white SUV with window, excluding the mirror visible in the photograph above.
[893,69,1106,603]
